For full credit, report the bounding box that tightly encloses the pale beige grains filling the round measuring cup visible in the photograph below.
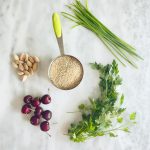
[49,55,83,90]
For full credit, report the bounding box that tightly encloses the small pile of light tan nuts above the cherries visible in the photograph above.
[12,53,40,82]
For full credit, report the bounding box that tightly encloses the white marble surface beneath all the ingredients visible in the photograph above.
[0,0,150,150]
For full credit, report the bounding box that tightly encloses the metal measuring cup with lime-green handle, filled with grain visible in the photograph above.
[48,13,84,90]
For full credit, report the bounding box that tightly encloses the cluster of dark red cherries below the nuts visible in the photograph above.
[21,94,52,132]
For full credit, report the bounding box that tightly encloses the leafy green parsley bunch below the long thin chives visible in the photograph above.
[68,61,136,142]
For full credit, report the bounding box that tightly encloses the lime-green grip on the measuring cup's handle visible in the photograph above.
[52,13,62,38]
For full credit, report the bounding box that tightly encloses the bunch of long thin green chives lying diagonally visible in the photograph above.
[62,0,142,68]
